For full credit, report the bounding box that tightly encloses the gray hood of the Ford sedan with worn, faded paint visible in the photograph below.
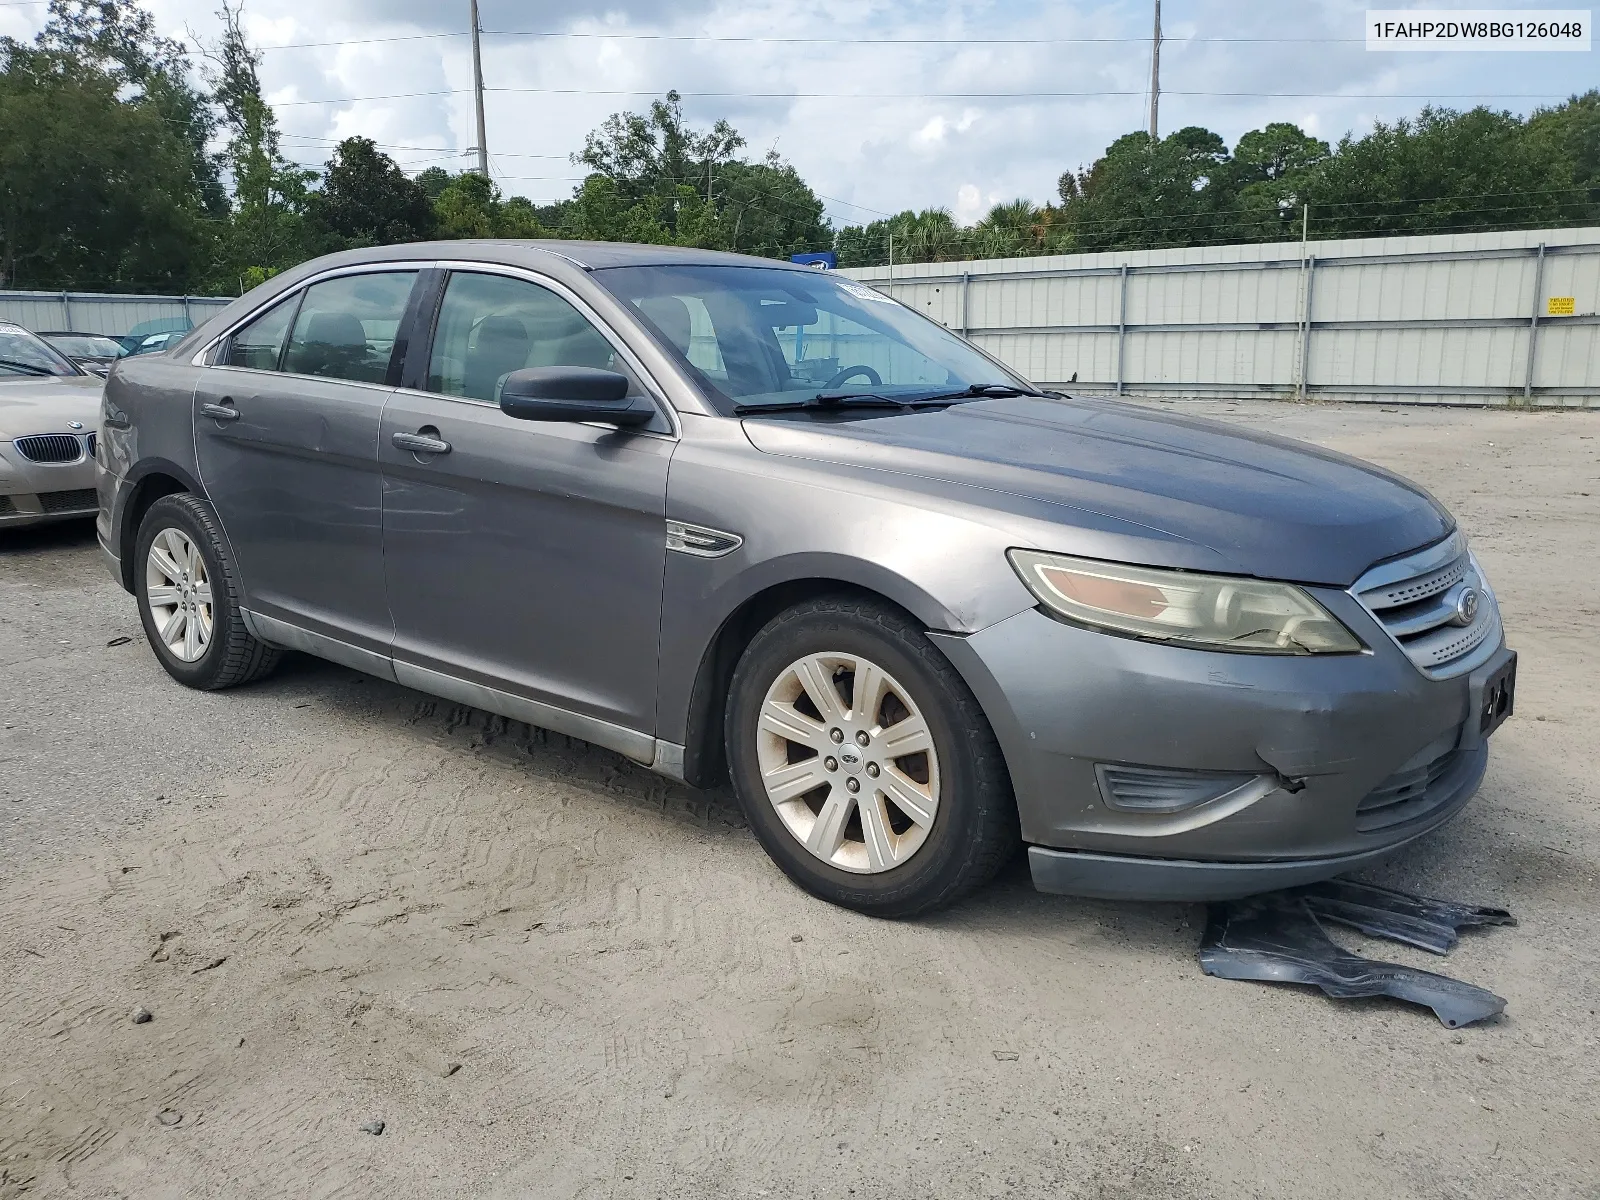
[744,397,1454,587]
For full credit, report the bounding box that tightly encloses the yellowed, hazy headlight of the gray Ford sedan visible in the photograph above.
[1008,550,1362,654]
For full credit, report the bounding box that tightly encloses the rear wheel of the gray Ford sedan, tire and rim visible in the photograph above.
[133,493,283,691]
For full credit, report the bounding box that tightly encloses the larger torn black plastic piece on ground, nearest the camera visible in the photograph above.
[1200,890,1509,1029]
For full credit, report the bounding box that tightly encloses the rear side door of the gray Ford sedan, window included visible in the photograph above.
[194,267,419,659]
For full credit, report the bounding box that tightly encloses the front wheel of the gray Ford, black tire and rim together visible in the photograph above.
[723,597,1019,917]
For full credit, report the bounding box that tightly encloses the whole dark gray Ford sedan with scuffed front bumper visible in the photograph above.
[99,242,1515,915]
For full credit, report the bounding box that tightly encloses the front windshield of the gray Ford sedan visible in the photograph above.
[594,266,1021,416]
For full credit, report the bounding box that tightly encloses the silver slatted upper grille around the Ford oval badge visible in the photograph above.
[1350,533,1501,678]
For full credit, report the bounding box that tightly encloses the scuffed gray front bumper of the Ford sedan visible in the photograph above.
[933,589,1510,901]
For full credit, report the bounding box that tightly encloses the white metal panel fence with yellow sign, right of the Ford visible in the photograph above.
[846,229,1600,406]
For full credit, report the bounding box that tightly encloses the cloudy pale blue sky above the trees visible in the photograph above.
[0,0,1600,224]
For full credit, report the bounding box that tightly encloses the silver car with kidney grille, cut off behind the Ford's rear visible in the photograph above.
[0,322,101,530]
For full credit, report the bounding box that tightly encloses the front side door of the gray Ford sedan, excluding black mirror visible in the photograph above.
[379,269,677,739]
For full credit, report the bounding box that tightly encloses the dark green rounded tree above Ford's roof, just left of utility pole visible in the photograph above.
[307,138,435,246]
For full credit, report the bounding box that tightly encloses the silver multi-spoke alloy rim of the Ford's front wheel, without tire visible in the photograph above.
[757,653,939,874]
